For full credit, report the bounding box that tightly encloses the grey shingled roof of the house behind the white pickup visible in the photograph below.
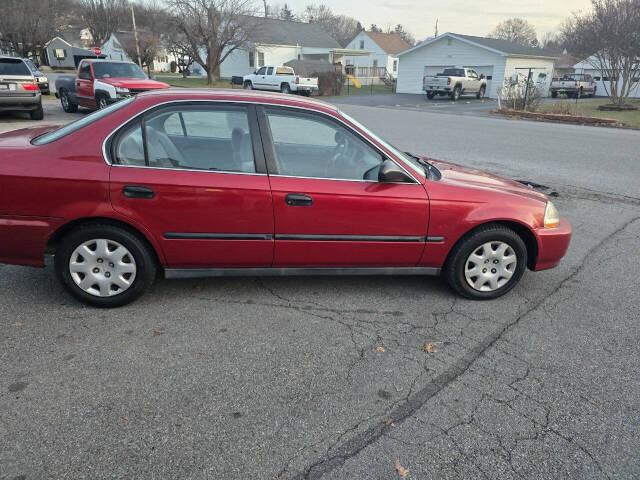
[244,17,340,48]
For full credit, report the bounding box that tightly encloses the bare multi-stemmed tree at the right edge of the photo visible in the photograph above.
[562,0,640,105]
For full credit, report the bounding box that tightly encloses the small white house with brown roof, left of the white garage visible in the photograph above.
[345,30,411,78]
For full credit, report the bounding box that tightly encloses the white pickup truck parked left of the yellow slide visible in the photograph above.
[242,65,318,97]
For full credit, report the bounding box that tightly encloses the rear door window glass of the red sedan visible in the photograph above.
[116,105,256,173]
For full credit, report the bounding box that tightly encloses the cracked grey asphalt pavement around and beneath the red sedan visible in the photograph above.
[0,99,640,480]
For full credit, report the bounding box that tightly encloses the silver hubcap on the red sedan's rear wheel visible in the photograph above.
[69,238,136,297]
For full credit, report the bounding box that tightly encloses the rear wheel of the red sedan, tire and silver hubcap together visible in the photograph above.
[55,224,156,307]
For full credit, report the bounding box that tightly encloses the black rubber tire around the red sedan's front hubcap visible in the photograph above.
[442,224,527,300]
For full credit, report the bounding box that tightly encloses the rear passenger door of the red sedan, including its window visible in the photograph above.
[110,103,274,268]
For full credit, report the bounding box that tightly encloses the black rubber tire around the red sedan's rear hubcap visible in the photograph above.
[55,224,157,308]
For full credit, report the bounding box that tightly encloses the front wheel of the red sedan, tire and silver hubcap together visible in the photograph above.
[443,225,527,300]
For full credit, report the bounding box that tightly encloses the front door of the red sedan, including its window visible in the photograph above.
[261,107,429,267]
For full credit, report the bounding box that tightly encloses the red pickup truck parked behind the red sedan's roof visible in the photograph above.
[56,58,169,112]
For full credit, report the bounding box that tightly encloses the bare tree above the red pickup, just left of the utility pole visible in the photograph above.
[77,0,131,45]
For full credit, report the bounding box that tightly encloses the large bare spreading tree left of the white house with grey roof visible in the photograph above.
[168,0,260,85]
